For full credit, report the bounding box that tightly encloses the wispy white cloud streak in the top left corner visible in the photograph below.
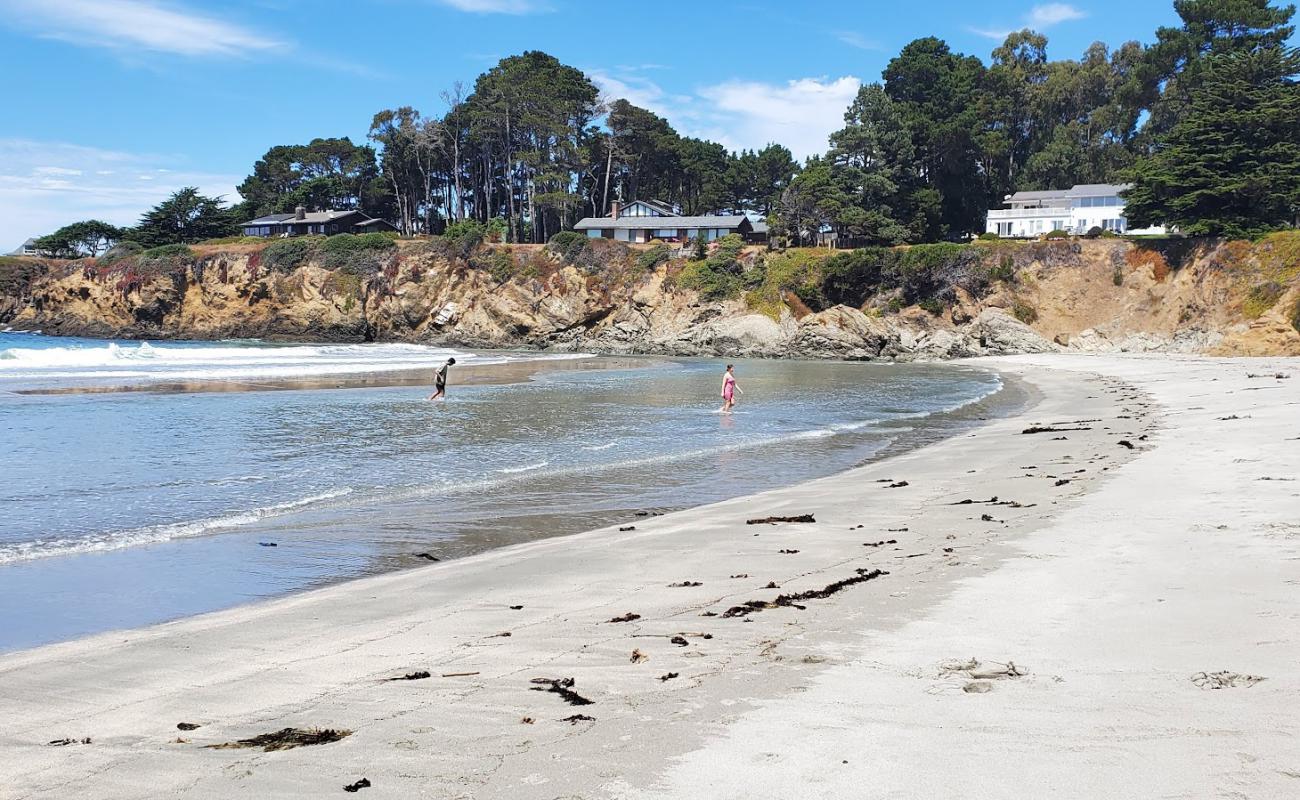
[0,0,283,57]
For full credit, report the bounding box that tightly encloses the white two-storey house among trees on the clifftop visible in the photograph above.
[985,183,1165,238]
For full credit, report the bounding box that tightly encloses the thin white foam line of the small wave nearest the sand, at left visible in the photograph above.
[0,489,352,565]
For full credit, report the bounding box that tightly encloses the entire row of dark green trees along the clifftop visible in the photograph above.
[27,0,1300,254]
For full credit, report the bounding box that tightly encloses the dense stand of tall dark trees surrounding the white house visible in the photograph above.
[774,0,1300,245]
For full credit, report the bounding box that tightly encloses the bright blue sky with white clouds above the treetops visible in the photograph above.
[0,0,1196,252]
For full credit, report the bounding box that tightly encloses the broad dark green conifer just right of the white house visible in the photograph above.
[1125,44,1300,237]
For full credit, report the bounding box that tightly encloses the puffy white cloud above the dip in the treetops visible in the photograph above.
[586,69,862,159]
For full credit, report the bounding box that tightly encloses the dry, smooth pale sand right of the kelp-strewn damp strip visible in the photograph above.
[636,356,1300,799]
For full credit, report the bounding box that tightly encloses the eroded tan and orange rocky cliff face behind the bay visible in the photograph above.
[0,234,1300,359]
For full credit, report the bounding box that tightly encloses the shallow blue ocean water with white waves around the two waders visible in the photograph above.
[0,333,1006,649]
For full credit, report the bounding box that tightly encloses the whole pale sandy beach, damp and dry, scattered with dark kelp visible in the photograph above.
[0,355,1300,799]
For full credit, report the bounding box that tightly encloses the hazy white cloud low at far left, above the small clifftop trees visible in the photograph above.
[0,139,242,252]
